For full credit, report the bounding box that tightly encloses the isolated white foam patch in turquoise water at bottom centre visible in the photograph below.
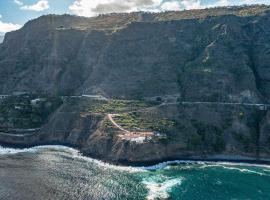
[142,175,183,200]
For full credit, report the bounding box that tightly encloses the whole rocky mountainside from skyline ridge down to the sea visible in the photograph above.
[0,6,270,166]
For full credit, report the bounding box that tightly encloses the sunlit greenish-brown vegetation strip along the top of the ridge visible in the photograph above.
[49,5,270,34]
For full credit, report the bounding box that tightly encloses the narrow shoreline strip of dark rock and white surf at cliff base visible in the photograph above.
[0,142,270,169]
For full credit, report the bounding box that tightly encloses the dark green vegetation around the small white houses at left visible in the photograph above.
[0,95,62,131]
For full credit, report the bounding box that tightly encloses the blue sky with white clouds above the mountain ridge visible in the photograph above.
[0,0,270,35]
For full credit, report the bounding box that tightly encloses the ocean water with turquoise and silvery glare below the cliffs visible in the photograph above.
[0,146,270,200]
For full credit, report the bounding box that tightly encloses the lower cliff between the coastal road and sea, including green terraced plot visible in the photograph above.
[0,97,270,164]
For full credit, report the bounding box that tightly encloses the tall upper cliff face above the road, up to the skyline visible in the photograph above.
[0,6,270,102]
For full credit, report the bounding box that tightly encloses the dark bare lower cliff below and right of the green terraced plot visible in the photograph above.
[82,105,270,163]
